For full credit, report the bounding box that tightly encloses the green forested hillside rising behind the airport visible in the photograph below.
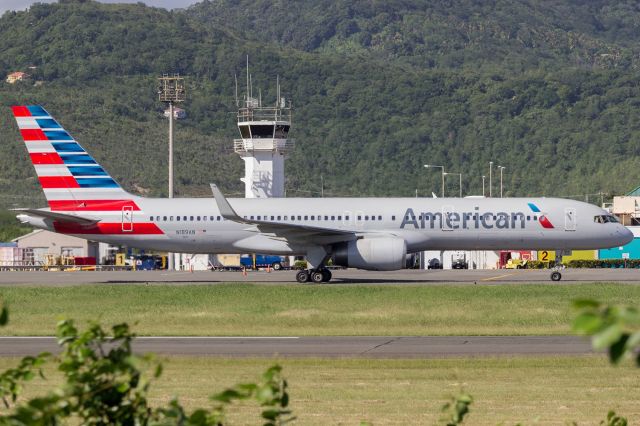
[0,0,640,211]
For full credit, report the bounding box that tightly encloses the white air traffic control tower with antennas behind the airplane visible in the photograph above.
[233,80,294,198]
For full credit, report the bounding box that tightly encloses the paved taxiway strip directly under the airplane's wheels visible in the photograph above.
[0,268,640,286]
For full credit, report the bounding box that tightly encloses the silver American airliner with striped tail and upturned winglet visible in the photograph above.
[12,105,633,283]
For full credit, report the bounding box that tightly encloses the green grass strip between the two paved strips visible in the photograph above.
[0,283,640,336]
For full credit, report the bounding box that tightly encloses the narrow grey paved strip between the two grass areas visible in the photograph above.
[0,336,592,358]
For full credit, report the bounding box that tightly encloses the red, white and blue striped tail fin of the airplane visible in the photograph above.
[11,105,135,211]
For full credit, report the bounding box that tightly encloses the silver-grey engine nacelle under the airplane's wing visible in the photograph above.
[332,237,407,271]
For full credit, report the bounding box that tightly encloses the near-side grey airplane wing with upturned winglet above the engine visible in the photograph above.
[211,183,358,244]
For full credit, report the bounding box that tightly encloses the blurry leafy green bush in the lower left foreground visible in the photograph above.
[0,311,293,426]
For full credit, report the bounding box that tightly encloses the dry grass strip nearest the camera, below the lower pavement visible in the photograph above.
[0,356,640,425]
